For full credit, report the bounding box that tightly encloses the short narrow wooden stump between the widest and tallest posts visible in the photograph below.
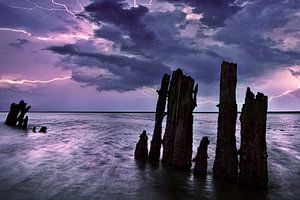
[193,137,210,178]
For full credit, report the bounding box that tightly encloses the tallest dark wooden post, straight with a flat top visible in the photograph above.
[213,61,238,182]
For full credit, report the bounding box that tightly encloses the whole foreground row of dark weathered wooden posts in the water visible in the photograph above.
[135,61,268,188]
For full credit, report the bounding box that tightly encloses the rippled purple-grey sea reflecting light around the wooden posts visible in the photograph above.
[0,113,300,200]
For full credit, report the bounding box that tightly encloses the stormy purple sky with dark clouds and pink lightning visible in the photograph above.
[0,0,300,111]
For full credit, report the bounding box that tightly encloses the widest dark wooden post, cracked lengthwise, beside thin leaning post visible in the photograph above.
[162,69,198,170]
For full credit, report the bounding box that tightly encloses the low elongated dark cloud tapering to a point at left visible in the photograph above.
[48,45,171,91]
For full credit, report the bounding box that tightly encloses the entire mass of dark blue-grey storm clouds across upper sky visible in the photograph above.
[49,0,300,93]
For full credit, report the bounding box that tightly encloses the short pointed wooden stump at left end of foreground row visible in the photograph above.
[134,130,148,161]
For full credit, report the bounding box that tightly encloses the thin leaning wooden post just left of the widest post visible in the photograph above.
[148,74,170,162]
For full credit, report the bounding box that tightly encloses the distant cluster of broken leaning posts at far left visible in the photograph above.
[5,100,31,129]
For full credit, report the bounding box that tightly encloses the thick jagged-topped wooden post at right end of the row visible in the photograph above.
[238,88,268,189]
